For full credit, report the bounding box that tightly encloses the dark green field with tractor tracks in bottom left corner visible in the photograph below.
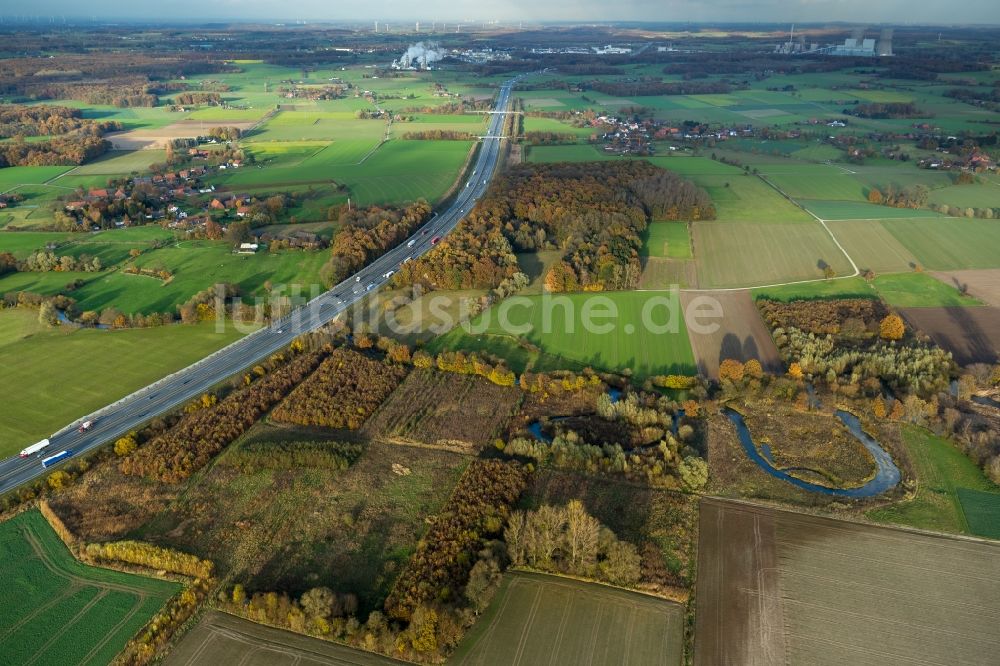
[0,511,180,666]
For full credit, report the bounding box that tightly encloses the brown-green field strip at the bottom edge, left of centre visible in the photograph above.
[163,611,402,666]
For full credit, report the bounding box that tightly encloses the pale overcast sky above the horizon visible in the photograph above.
[0,0,1000,24]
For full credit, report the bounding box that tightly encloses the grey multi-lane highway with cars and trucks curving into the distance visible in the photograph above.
[0,77,520,493]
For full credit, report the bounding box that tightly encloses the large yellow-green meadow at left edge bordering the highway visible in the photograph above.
[0,308,248,457]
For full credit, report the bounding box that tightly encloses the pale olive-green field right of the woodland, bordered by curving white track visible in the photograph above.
[692,221,852,288]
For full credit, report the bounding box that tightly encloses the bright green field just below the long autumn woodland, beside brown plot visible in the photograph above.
[452,292,695,377]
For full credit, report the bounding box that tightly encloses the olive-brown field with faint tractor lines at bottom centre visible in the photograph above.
[449,573,685,666]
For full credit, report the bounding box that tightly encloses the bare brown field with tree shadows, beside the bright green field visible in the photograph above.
[681,291,784,379]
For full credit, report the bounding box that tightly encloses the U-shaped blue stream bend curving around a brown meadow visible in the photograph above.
[723,407,901,497]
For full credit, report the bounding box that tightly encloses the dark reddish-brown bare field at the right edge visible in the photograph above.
[900,306,1000,365]
